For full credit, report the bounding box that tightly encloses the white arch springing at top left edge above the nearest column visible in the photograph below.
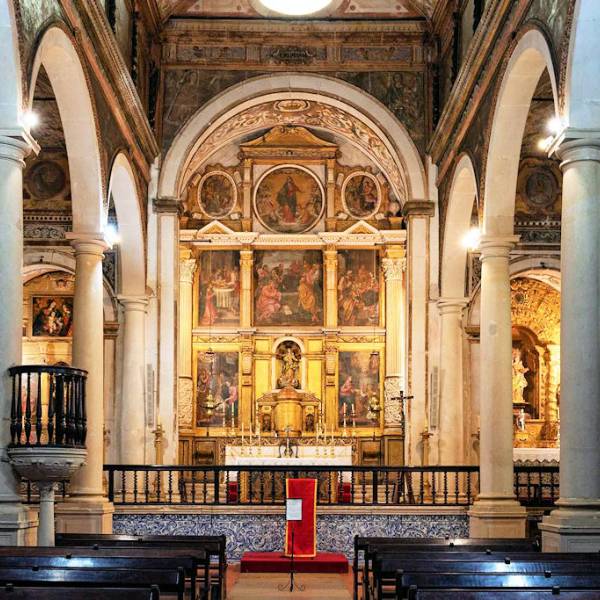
[0,0,27,135]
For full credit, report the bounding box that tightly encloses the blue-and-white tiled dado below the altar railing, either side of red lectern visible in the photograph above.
[113,510,469,561]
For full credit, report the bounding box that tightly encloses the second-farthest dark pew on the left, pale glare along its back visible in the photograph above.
[0,546,210,598]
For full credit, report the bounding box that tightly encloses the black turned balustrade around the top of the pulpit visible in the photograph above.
[8,365,87,448]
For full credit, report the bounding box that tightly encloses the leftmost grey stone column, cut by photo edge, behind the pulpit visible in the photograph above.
[0,136,37,545]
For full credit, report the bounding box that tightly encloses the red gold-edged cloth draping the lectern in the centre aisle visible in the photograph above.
[285,479,317,558]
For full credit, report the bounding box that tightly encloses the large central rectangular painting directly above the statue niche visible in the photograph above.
[254,250,323,326]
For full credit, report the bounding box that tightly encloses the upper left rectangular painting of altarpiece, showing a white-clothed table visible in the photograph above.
[198,250,240,327]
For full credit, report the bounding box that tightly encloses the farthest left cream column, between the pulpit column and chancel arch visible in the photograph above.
[115,296,153,465]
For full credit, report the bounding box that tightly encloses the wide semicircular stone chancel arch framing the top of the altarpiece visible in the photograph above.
[158,74,428,200]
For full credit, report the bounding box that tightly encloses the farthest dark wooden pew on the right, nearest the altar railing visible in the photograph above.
[353,535,540,600]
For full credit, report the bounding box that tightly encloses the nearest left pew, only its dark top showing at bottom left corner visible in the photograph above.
[0,584,160,600]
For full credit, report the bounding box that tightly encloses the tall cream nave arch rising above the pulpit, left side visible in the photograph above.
[29,26,106,235]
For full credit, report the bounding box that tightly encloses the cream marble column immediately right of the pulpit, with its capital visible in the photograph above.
[70,233,108,502]
